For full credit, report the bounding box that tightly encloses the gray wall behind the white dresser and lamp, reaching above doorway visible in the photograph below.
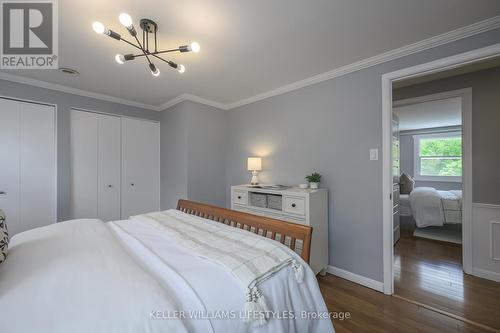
[226,30,500,281]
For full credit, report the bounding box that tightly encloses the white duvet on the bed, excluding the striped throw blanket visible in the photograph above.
[0,214,333,333]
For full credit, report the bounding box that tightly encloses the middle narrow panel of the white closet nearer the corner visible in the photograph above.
[97,115,121,221]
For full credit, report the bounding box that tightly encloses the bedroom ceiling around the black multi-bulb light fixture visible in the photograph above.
[0,0,500,106]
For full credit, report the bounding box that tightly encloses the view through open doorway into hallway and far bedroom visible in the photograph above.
[392,57,500,327]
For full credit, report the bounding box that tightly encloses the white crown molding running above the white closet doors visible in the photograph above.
[0,72,163,111]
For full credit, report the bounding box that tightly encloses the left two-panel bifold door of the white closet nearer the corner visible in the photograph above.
[71,110,121,221]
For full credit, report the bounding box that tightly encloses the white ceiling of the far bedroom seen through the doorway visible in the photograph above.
[394,97,462,131]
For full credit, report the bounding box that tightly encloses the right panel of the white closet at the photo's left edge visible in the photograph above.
[19,103,57,231]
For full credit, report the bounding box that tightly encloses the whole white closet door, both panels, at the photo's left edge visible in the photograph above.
[0,99,56,235]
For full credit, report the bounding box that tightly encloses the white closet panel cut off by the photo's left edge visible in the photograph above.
[0,99,21,234]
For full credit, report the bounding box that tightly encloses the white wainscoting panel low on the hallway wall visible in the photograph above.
[472,203,500,282]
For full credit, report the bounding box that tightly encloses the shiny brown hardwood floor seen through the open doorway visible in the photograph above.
[394,237,500,332]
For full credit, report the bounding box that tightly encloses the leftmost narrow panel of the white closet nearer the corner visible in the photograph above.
[71,110,99,219]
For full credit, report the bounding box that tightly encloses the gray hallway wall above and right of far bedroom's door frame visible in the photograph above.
[393,67,500,204]
